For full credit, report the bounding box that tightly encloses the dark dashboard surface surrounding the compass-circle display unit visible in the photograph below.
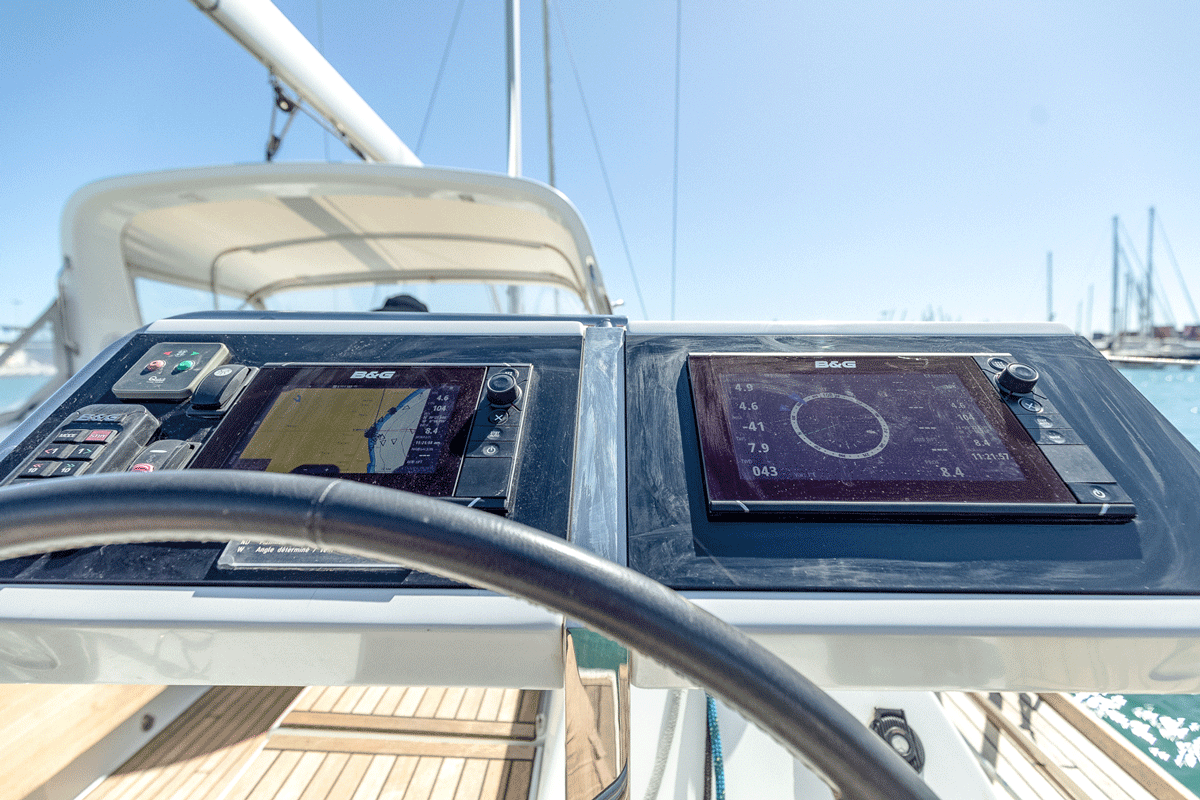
[625,332,1200,595]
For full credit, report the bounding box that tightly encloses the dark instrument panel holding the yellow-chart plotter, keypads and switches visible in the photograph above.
[0,326,582,587]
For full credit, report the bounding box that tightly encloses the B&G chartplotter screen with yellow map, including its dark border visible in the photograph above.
[197,366,486,497]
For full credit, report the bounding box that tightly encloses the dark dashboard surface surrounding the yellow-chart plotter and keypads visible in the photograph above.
[0,314,582,587]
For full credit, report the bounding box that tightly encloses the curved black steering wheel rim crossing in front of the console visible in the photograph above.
[0,470,936,800]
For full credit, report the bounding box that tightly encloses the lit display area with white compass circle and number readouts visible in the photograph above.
[721,369,1025,482]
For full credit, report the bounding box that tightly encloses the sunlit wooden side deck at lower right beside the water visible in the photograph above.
[940,692,1196,800]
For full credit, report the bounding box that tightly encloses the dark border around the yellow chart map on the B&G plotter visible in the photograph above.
[192,363,487,497]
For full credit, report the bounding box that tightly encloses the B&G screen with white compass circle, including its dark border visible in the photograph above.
[689,354,1074,513]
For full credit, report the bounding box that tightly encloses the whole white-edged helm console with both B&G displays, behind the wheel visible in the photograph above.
[7,312,1200,691]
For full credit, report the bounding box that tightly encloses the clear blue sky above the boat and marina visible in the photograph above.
[0,0,1200,327]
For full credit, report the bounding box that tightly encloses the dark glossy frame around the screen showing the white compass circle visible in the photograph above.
[688,353,1078,515]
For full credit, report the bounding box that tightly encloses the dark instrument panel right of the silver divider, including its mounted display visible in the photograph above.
[625,326,1200,595]
